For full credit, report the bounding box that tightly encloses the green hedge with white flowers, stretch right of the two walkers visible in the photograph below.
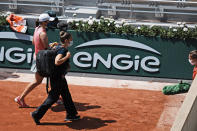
[67,17,197,40]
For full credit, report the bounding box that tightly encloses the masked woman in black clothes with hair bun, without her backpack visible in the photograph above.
[31,31,80,125]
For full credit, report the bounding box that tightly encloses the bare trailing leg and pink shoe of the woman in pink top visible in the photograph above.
[15,72,43,107]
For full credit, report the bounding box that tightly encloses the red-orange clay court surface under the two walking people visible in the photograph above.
[0,81,182,131]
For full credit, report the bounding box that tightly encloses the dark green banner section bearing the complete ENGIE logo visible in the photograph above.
[67,31,197,79]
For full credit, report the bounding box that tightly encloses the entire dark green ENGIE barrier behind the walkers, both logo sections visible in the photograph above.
[0,29,197,79]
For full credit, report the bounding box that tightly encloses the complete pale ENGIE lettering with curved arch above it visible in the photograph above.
[73,38,161,73]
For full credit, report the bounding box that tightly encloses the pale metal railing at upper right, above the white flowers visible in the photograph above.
[97,0,197,17]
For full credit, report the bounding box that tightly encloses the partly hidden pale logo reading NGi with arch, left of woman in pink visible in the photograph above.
[0,32,34,66]
